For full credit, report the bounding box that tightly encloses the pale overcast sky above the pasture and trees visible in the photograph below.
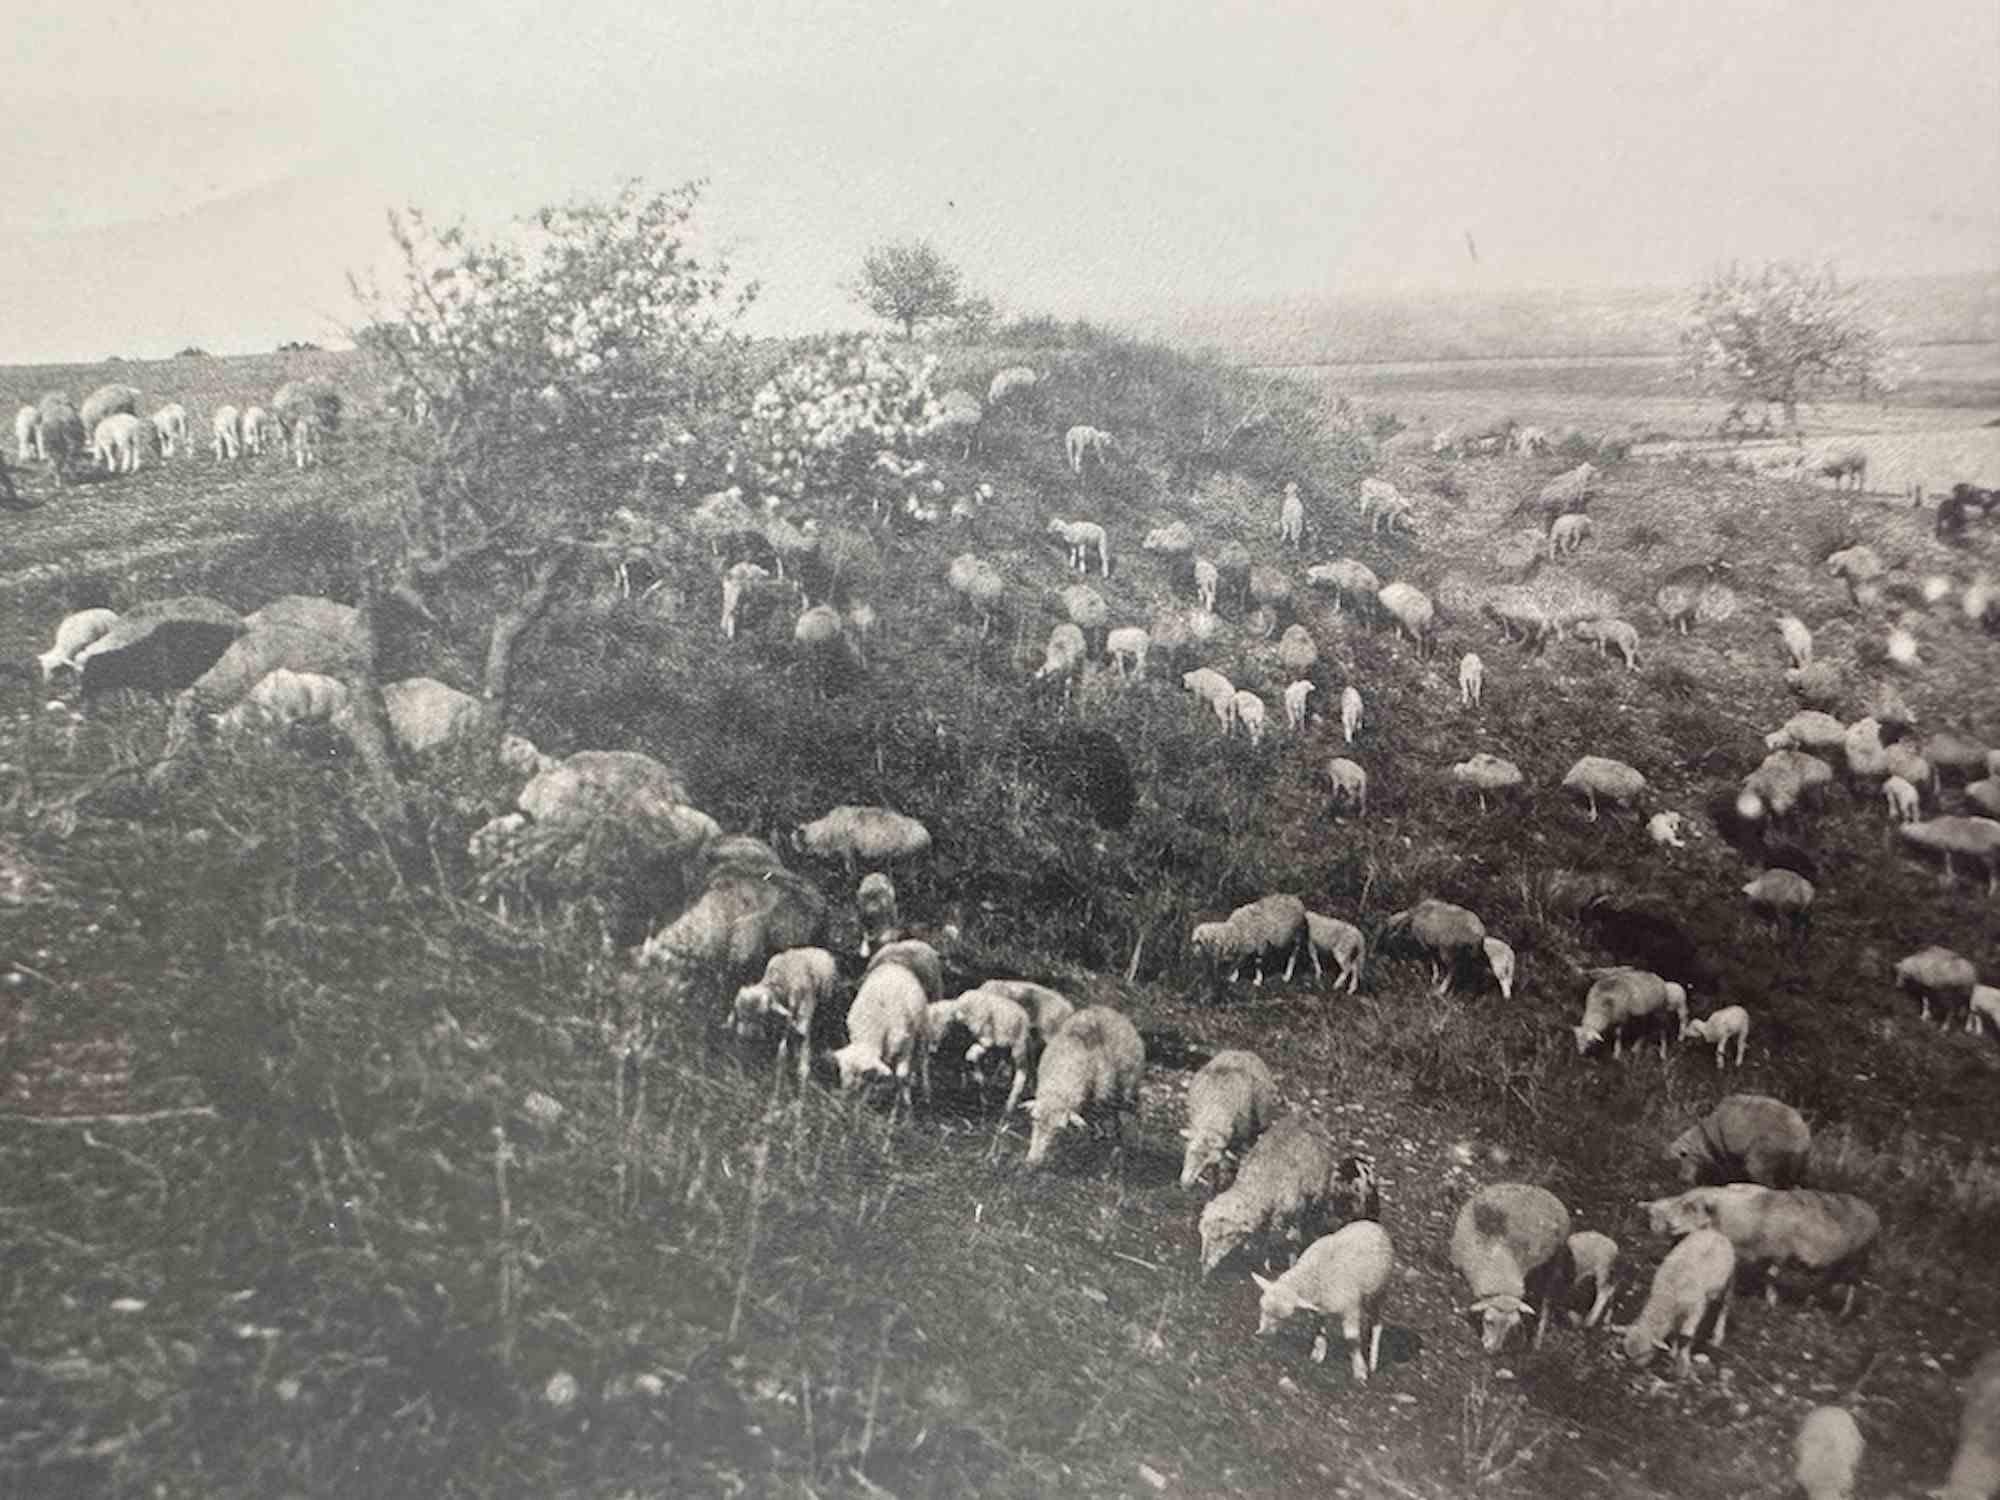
[0,0,2000,362]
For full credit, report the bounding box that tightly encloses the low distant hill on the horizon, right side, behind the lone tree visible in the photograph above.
[1130,272,2000,364]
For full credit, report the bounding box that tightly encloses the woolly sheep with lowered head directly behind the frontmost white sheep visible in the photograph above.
[1200,1112,1382,1276]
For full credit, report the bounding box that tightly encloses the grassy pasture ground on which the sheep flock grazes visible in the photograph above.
[0,332,2000,1500]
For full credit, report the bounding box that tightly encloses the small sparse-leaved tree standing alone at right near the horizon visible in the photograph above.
[1680,260,1892,434]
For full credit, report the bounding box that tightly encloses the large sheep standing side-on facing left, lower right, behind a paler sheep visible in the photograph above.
[1644,1182,1882,1316]
